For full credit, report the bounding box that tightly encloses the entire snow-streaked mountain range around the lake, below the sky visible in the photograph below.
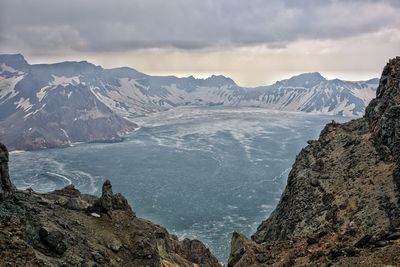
[0,54,378,149]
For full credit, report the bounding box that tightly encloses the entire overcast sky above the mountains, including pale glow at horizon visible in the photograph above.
[0,0,400,86]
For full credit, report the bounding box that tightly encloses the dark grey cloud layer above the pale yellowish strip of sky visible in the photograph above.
[0,0,400,54]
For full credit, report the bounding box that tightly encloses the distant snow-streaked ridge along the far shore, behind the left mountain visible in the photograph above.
[90,70,378,117]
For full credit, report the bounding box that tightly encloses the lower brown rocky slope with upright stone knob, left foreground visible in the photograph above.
[0,144,220,267]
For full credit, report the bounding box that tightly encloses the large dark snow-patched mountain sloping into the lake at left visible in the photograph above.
[0,55,137,149]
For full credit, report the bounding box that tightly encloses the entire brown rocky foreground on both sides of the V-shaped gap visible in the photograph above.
[0,57,400,267]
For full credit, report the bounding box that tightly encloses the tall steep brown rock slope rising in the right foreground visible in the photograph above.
[229,57,400,266]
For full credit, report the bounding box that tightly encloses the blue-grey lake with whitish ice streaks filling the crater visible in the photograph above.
[10,107,348,262]
